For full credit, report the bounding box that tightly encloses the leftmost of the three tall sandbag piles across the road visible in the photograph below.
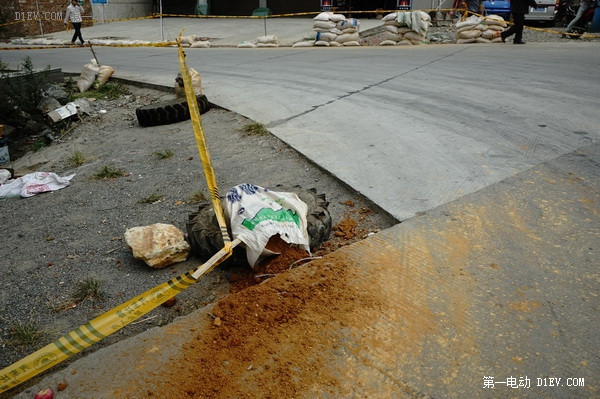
[313,12,360,46]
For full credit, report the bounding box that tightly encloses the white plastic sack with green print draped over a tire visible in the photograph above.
[224,184,310,266]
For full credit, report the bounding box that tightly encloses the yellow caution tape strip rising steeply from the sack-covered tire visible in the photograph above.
[177,29,231,247]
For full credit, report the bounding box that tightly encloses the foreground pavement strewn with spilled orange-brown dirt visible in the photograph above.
[11,144,600,399]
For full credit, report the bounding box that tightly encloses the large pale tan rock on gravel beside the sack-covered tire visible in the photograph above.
[125,223,190,269]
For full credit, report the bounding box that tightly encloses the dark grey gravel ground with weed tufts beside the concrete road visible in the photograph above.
[0,81,396,397]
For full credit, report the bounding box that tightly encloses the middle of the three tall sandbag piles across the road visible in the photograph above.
[379,11,431,46]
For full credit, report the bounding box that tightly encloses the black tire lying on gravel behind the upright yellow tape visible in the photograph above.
[135,94,211,127]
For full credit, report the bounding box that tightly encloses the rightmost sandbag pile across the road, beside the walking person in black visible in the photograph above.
[456,15,507,44]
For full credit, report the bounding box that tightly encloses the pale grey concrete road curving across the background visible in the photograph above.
[0,42,600,220]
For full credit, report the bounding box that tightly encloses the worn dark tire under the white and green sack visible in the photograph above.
[186,185,332,264]
